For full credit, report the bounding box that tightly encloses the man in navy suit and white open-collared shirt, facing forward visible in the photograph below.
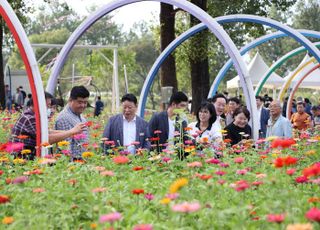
[103,94,150,153]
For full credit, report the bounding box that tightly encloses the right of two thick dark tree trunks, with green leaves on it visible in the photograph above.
[189,0,210,112]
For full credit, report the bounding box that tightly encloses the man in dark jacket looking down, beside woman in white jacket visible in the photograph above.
[149,92,188,152]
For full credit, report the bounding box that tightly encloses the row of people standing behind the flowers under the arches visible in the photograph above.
[12,86,320,160]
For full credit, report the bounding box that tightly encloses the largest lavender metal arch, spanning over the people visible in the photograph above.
[47,0,260,138]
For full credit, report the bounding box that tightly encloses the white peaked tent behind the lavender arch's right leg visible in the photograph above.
[227,52,284,89]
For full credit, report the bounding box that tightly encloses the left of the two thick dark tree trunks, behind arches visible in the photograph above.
[160,3,178,91]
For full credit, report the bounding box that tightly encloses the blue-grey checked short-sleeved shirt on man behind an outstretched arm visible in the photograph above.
[55,105,88,157]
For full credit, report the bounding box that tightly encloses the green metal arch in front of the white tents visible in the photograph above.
[255,42,320,95]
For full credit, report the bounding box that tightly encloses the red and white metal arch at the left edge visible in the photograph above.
[0,0,48,157]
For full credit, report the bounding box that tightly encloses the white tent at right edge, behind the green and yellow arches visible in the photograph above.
[284,54,320,89]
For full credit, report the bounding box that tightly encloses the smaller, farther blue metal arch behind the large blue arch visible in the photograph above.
[208,30,320,98]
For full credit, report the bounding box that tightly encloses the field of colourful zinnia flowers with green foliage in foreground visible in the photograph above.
[0,110,320,230]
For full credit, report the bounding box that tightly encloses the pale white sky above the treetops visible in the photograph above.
[32,0,160,31]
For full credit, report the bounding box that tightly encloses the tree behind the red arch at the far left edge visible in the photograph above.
[0,0,30,108]
